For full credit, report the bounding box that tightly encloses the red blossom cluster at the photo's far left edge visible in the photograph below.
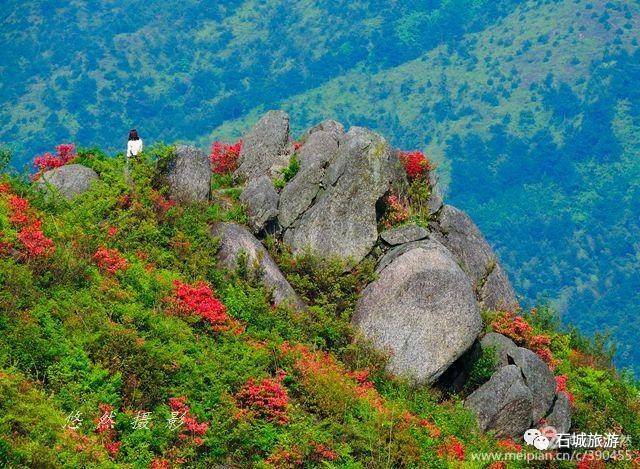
[0,184,55,259]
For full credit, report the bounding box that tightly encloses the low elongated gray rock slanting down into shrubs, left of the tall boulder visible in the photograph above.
[211,222,306,309]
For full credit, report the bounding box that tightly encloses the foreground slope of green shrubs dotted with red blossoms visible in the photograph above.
[0,146,640,468]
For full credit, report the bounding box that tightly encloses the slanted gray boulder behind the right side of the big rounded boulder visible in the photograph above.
[438,205,517,309]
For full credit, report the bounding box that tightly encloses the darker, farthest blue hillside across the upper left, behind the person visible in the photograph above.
[0,0,517,164]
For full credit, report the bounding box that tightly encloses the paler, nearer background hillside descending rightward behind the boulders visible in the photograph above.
[205,0,640,367]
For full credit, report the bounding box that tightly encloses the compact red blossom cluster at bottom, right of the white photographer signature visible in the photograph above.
[235,372,289,424]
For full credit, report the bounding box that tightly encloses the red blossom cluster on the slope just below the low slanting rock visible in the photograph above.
[171,280,230,332]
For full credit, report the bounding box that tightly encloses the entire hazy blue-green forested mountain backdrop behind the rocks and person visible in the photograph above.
[0,0,640,372]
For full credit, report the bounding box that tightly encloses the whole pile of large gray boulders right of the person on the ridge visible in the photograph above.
[230,111,536,435]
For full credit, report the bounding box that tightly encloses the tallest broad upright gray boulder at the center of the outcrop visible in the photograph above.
[284,127,400,264]
